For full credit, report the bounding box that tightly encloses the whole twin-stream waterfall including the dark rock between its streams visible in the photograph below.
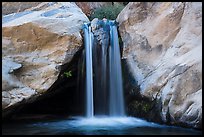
[83,20,125,117]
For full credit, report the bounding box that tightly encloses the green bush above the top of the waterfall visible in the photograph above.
[89,4,125,20]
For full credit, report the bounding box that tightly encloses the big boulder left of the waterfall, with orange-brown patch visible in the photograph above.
[2,2,89,115]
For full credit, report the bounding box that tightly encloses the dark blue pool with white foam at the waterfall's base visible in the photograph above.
[2,116,202,135]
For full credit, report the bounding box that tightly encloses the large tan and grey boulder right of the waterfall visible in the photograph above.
[117,2,202,128]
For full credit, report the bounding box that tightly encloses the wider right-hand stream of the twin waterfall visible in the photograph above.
[109,22,125,116]
